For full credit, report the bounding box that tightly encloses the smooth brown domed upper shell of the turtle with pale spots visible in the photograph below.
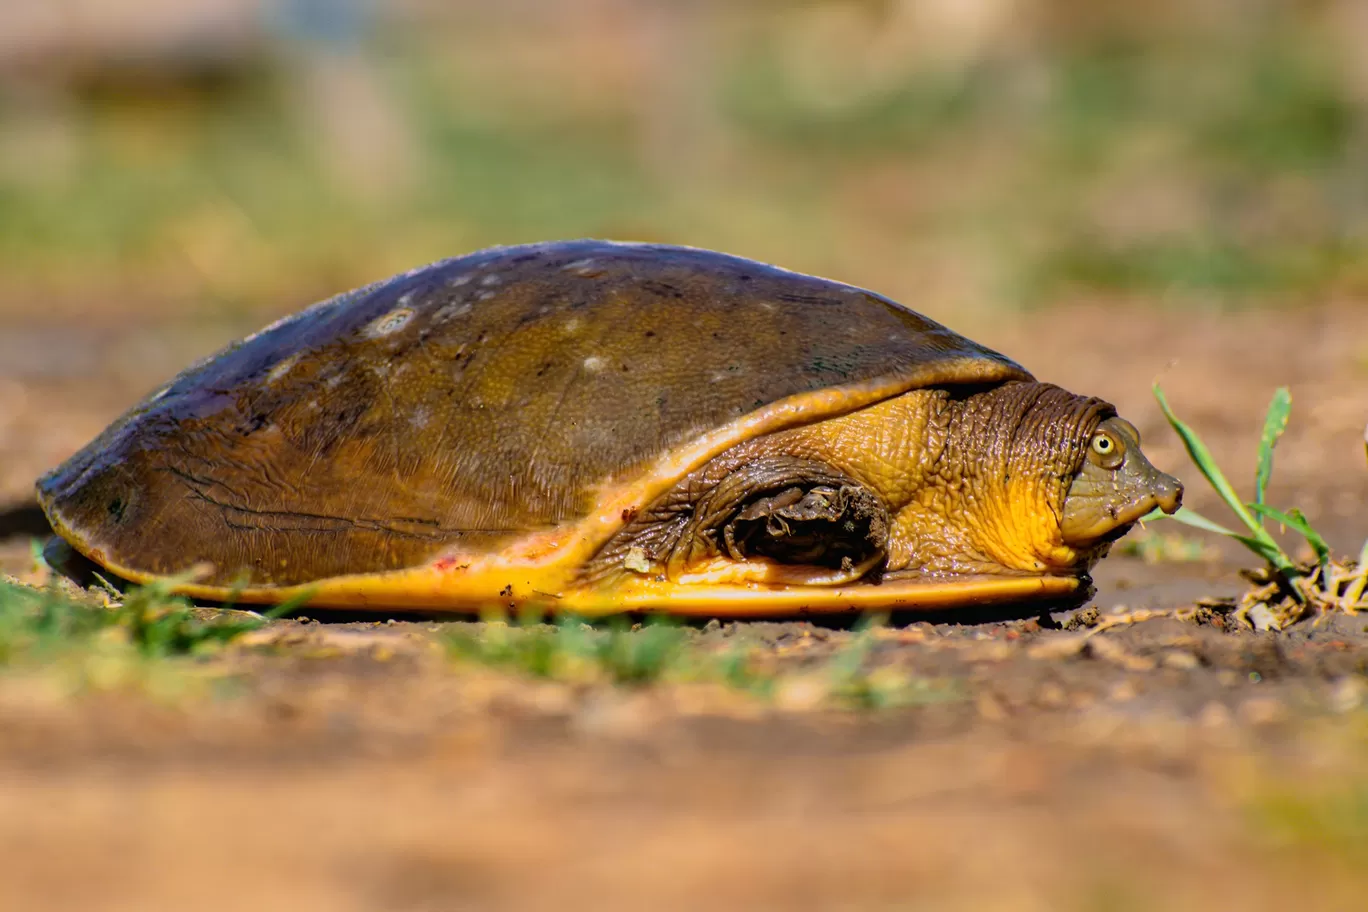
[38,241,1030,601]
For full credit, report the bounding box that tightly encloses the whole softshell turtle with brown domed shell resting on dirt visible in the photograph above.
[38,241,1182,615]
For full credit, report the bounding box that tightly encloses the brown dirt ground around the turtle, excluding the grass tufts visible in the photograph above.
[0,304,1368,912]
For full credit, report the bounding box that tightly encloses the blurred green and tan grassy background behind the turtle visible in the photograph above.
[0,0,1368,319]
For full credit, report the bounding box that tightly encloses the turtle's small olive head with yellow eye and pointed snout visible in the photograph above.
[1060,417,1183,547]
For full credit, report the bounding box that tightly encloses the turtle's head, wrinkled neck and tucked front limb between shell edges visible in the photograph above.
[587,381,1182,585]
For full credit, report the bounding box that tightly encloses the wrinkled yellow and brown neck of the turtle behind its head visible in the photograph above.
[798,383,1114,577]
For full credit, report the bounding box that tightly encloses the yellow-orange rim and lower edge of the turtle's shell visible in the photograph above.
[56,357,1079,617]
